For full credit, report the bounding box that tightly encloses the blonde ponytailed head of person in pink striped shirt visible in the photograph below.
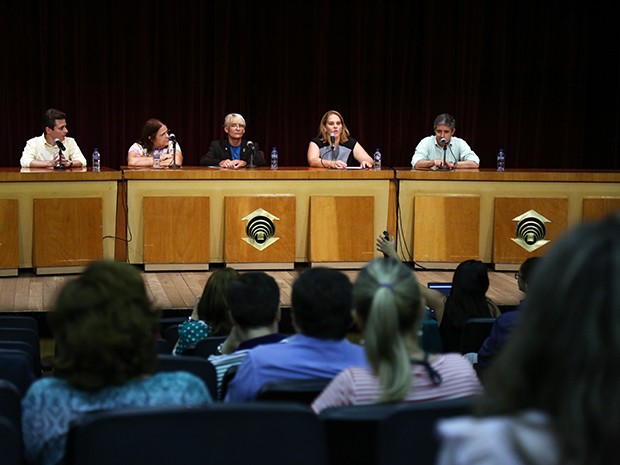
[353,258,423,402]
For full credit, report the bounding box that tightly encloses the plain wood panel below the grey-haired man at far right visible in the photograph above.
[413,195,480,264]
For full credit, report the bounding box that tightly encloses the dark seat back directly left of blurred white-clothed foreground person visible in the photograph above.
[376,398,473,465]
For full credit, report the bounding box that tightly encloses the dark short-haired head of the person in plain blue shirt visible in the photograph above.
[291,267,352,339]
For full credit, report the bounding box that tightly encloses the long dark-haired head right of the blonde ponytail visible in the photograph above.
[446,260,491,325]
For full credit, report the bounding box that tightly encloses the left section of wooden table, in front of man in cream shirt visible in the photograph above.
[0,168,121,273]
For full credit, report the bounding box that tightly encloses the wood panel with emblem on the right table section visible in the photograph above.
[493,197,568,269]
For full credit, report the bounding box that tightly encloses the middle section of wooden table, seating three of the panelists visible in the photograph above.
[123,166,395,263]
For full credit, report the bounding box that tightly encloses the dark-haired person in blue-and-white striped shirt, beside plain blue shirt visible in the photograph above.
[209,272,286,398]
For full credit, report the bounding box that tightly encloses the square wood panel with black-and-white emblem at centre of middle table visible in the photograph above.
[224,195,296,267]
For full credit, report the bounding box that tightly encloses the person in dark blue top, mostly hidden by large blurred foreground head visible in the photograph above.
[476,257,542,368]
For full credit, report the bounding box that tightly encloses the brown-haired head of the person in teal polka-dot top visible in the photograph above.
[197,267,240,336]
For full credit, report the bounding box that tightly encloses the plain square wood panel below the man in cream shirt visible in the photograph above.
[33,198,103,272]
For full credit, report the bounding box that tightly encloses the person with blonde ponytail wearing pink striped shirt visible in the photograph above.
[312,258,482,413]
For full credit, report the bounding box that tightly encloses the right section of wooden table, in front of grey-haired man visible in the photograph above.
[397,168,620,269]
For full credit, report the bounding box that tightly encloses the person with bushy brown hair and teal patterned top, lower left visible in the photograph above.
[22,261,211,465]
